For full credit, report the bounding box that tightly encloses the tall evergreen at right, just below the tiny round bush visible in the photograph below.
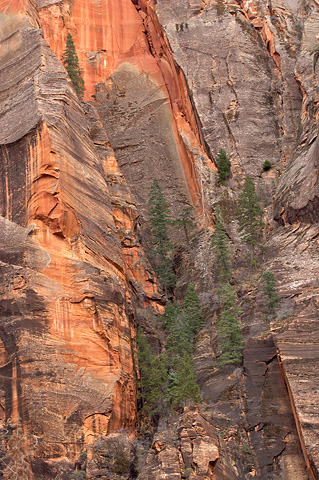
[237,175,265,258]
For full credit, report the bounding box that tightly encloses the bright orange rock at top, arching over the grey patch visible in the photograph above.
[39,0,218,219]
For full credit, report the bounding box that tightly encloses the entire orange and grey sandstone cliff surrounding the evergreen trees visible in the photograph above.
[0,0,319,480]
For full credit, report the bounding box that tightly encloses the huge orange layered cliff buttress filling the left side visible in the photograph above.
[0,4,162,478]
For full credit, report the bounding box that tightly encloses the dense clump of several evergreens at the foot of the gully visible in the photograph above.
[137,283,205,415]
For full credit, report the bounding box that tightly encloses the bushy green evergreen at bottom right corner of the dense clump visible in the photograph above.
[168,352,202,407]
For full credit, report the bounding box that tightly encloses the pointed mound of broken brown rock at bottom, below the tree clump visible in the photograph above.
[138,405,238,480]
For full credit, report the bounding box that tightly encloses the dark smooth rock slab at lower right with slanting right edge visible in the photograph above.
[244,337,309,480]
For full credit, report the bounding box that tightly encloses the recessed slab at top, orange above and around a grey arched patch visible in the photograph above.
[39,0,214,223]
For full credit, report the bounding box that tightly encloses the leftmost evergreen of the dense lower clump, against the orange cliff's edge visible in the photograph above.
[136,328,168,415]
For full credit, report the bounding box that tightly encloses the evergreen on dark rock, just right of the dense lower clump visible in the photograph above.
[218,282,242,366]
